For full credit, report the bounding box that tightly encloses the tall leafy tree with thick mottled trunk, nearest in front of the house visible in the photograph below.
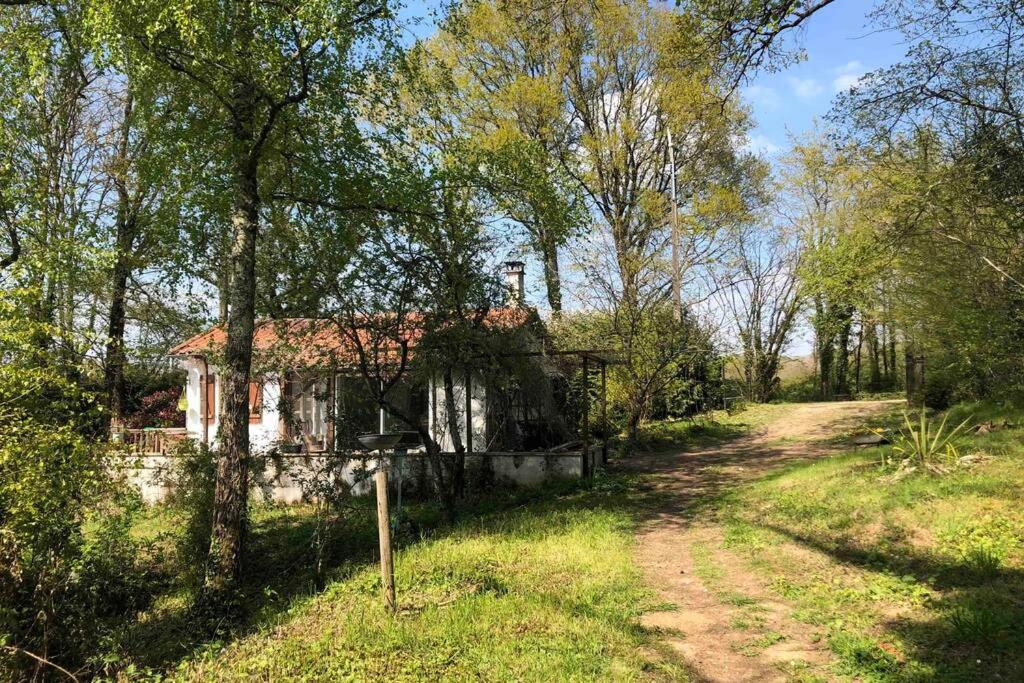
[90,0,399,603]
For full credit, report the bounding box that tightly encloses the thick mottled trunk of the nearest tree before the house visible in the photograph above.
[205,66,260,605]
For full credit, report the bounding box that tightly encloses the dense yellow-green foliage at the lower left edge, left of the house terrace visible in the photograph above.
[0,291,146,678]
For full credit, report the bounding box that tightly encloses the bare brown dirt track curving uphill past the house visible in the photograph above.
[630,401,892,683]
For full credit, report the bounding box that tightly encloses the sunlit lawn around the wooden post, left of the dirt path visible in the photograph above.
[103,476,686,681]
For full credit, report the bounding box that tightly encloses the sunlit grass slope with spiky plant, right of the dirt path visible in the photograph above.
[701,404,1024,681]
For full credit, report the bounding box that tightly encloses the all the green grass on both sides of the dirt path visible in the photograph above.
[97,397,1024,681]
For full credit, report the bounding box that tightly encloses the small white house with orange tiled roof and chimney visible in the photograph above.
[142,262,594,501]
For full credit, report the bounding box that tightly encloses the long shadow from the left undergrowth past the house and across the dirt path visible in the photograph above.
[114,401,897,672]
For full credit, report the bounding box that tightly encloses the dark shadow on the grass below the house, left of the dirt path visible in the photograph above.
[120,474,684,673]
